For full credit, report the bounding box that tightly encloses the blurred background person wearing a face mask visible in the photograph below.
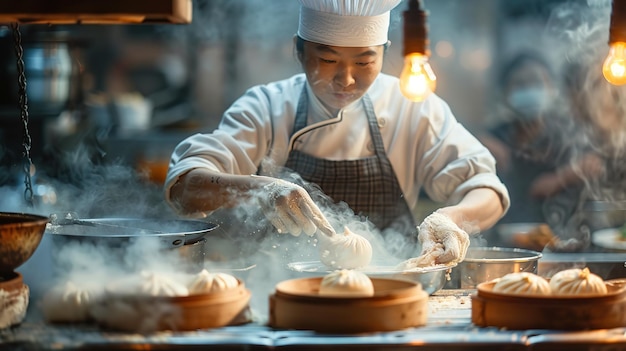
[479,52,603,249]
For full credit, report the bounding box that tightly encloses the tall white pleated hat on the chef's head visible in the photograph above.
[298,0,401,47]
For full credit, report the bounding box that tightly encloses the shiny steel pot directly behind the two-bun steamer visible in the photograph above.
[453,247,542,289]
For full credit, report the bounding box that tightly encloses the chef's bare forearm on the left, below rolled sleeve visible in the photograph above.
[170,168,257,214]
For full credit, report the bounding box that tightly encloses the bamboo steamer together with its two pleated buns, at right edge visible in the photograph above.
[471,268,626,330]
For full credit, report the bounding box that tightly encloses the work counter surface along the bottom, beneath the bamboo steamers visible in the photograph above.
[0,290,626,351]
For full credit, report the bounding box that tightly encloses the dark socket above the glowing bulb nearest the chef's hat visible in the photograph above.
[403,0,430,56]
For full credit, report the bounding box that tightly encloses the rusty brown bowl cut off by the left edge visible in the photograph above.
[0,212,48,280]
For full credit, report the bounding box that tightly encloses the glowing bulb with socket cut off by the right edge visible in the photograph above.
[602,0,626,85]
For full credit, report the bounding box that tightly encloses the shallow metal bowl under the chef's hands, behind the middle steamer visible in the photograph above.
[287,261,456,295]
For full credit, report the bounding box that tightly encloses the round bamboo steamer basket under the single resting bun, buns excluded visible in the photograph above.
[269,277,428,333]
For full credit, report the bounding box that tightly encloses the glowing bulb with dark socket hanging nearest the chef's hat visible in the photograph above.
[400,0,437,101]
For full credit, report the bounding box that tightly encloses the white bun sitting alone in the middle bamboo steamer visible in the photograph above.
[319,269,374,297]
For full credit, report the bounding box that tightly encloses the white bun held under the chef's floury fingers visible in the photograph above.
[319,227,372,269]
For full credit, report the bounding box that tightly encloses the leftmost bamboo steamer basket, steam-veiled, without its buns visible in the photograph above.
[95,279,251,333]
